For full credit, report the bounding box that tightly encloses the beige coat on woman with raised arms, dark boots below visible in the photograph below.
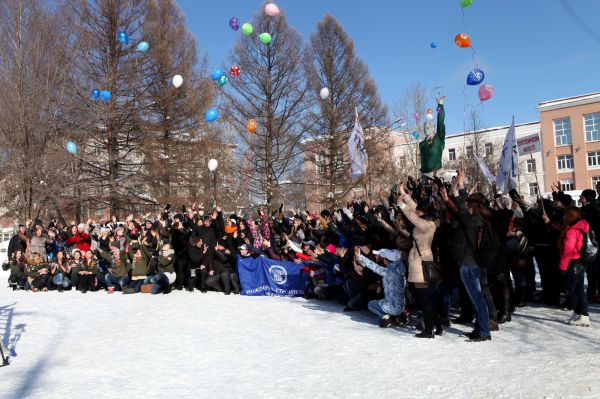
[399,195,437,283]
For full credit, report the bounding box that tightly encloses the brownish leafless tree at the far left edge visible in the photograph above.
[0,0,72,219]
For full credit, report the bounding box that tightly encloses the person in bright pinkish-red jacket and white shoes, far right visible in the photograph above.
[559,206,590,327]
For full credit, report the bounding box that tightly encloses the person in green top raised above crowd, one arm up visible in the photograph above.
[419,97,446,179]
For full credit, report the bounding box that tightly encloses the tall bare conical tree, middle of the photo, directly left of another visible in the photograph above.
[225,8,307,212]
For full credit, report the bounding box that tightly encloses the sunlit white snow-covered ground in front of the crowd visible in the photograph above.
[0,266,600,399]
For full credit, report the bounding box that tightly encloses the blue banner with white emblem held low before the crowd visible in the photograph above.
[238,256,304,296]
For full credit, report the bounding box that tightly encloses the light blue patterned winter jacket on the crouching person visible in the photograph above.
[358,255,406,316]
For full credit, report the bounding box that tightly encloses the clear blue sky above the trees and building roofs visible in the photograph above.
[177,0,600,134]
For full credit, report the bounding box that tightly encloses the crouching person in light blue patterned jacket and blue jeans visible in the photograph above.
[354,247,408,328]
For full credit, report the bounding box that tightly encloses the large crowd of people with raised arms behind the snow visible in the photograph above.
[3,171,600,342]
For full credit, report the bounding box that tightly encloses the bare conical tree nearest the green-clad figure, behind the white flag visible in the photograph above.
[305,15,391,203]
